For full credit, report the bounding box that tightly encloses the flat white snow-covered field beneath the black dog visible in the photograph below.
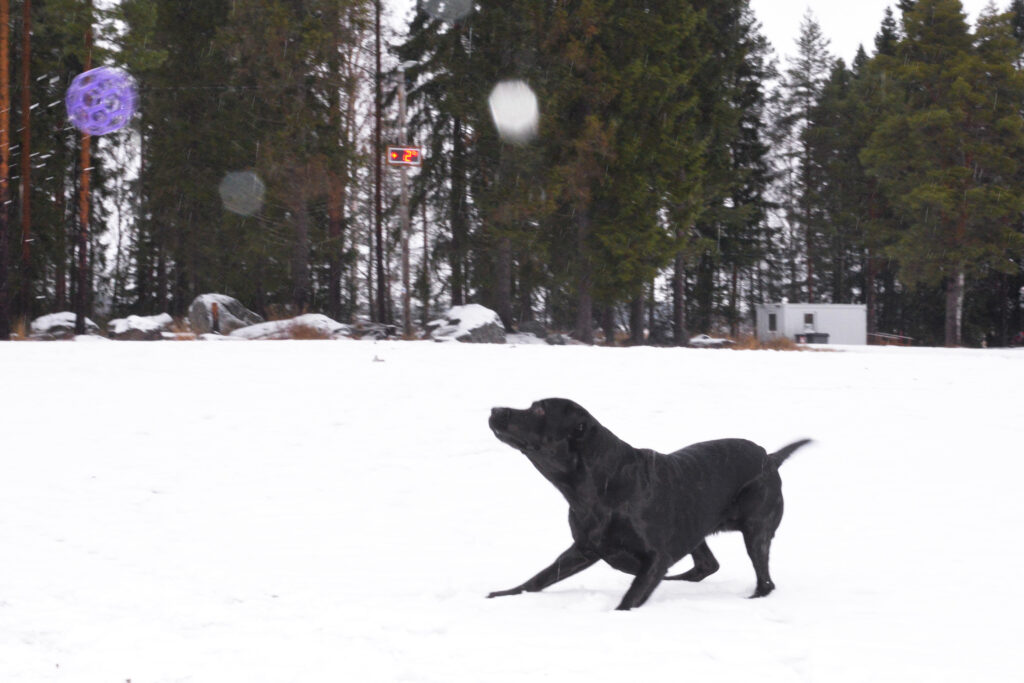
[0,341,1024,683]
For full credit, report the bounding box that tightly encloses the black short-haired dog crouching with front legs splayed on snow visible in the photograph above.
[487,398,809,609]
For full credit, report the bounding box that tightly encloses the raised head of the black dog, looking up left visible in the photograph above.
[487,398,597,485]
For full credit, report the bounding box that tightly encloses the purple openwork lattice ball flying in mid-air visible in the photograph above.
[65,67,138,135]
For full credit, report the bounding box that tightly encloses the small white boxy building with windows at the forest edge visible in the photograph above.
[755,300,867,344]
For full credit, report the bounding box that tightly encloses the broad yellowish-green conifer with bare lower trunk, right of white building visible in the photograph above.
[862,0,1024,346]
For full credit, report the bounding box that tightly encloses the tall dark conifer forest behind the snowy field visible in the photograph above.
[0,0,1024,346]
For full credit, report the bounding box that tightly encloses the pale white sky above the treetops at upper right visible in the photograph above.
[751,0,1010,65]
